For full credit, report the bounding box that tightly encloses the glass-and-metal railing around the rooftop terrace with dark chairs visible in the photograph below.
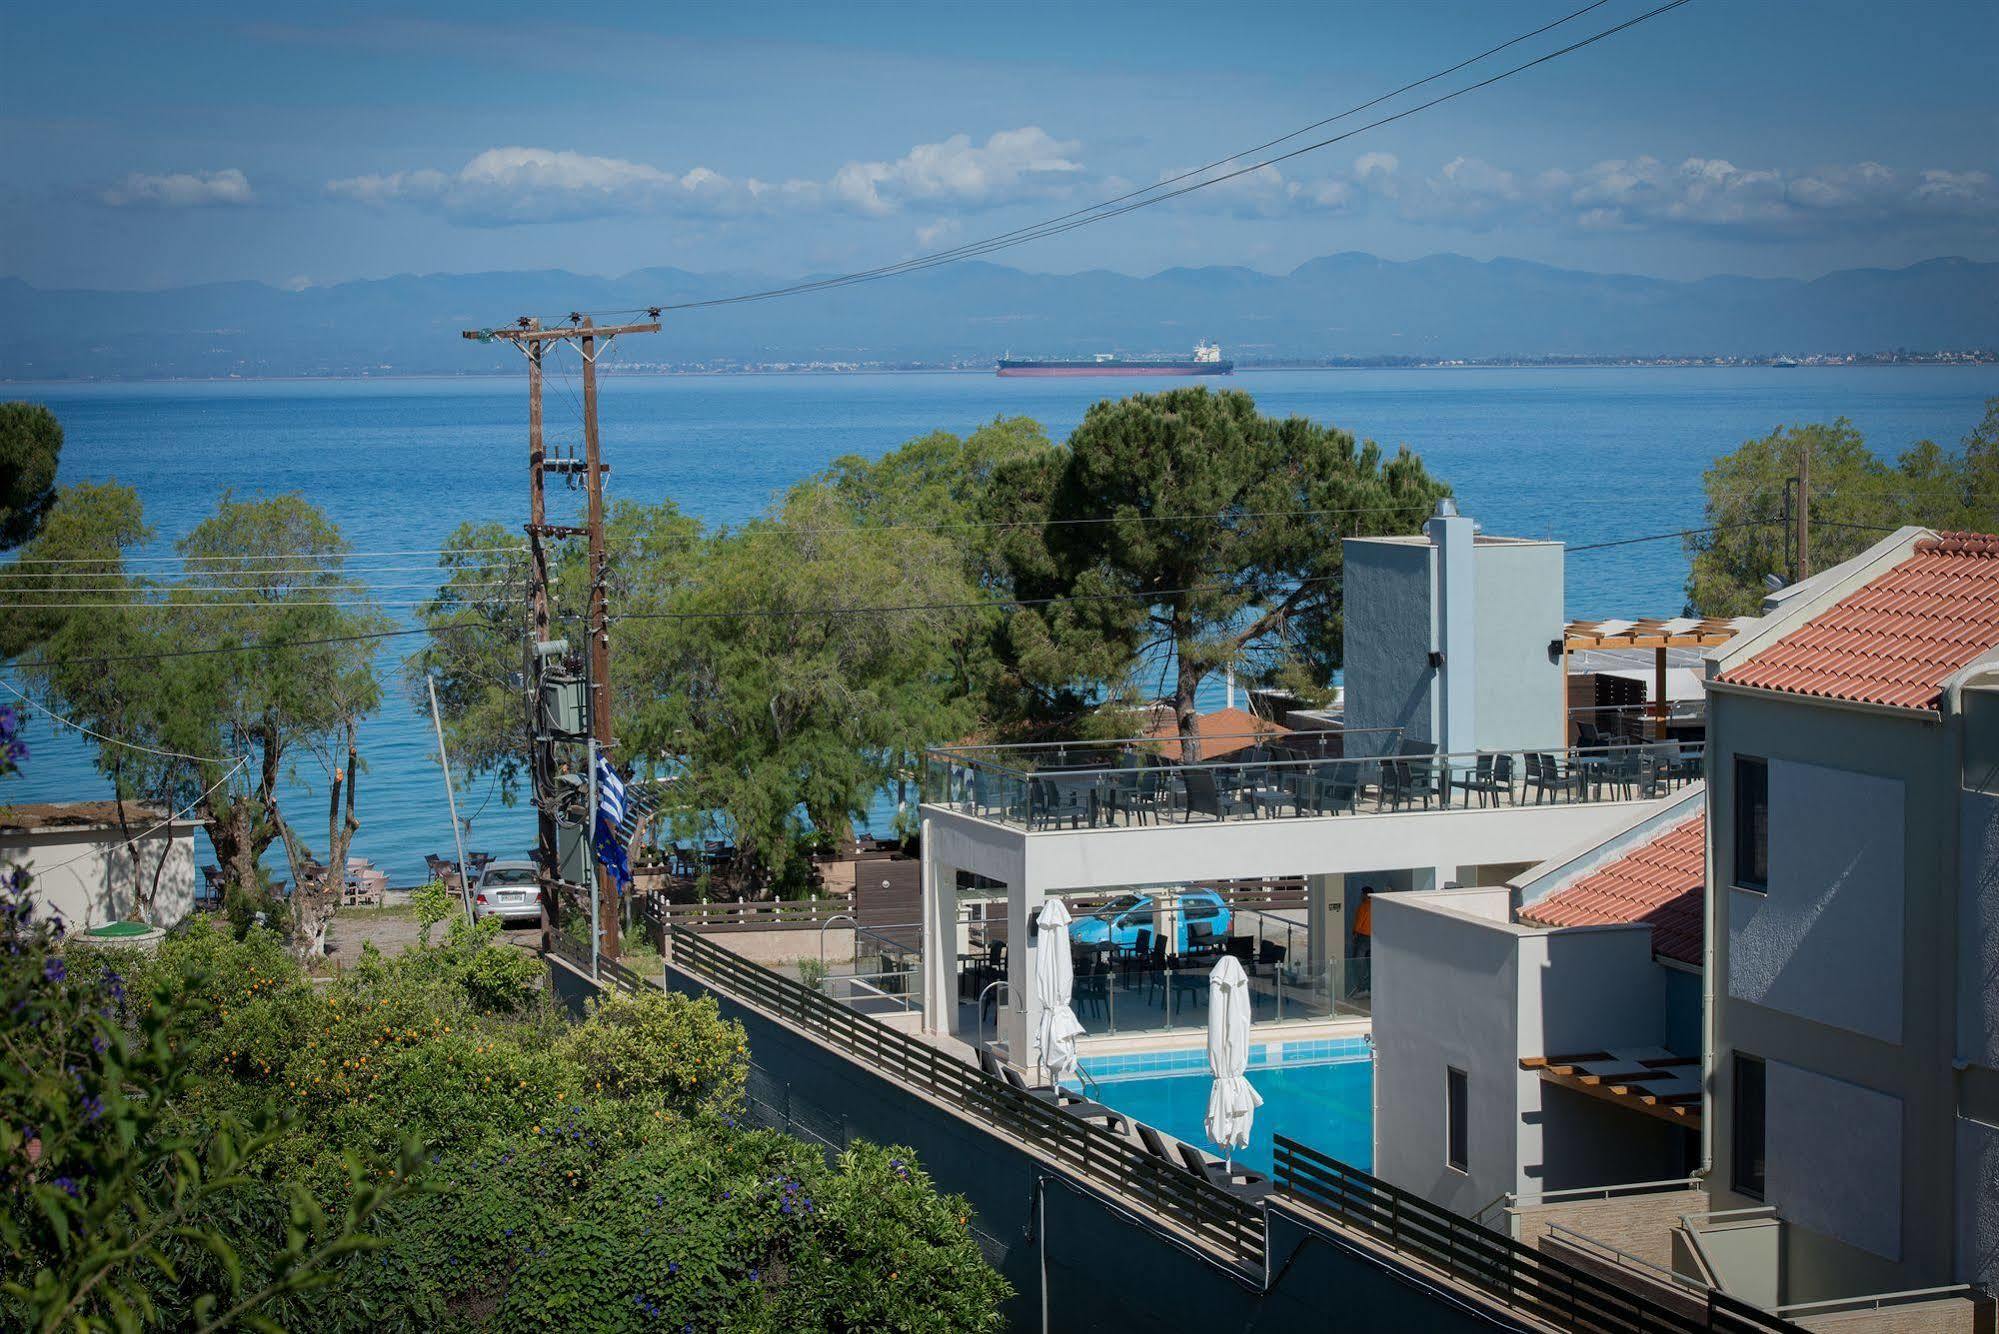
[924,740,1703,832]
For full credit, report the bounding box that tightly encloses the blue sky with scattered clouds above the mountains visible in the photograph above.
[0,0,1999,288]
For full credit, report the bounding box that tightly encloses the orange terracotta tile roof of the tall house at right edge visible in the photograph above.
[1721,532,1999,710]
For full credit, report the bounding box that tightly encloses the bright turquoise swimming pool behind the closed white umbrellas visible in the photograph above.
[1083,1038,1373,1172]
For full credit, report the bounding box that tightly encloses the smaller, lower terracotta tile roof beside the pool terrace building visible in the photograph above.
[1519,814,1707,966]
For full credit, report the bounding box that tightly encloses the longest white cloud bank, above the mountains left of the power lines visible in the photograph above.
[326,126,1081,226]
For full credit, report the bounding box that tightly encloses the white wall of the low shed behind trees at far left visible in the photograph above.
[0,824,196,930]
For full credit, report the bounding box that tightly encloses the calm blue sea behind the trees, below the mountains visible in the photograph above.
[0,366,1999,884]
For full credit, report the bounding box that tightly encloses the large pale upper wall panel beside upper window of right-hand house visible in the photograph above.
[1729,760,1903,1042]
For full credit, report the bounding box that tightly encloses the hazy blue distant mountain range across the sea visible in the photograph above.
[0,252,1999,380]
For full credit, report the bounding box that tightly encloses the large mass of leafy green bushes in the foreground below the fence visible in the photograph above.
[23,904,1007,1334]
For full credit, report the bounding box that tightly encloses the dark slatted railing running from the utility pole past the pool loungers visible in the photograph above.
[670,924,1265,1272]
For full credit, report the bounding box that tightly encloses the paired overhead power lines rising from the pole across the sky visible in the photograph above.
[559,0,1689,310]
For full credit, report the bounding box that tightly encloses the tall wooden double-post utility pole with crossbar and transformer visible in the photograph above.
[464,310,660,958]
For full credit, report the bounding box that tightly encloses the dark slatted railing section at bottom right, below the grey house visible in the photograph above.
[1273,1134,1799,1334]
